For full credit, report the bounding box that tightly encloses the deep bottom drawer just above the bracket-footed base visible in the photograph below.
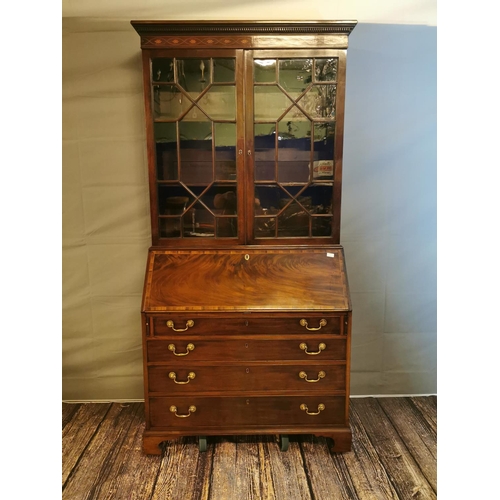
[149,395,345,429]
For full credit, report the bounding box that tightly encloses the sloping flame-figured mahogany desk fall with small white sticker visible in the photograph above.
[143,246,351,312]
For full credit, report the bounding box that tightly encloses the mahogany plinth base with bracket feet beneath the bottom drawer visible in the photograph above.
[142,426,352,455]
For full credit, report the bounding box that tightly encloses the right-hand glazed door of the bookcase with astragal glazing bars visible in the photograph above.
[245,50,345,244]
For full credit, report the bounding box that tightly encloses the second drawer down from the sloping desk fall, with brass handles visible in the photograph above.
[147,335,347,367]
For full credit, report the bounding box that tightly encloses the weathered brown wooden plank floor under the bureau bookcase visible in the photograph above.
[62,396,437,500]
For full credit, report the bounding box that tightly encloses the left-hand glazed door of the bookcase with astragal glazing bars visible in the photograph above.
[144,50,244,245]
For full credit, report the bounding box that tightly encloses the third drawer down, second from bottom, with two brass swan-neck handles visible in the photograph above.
[148,362,346,395]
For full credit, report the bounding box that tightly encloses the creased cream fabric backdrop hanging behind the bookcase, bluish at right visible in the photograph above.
[62,12,436,400]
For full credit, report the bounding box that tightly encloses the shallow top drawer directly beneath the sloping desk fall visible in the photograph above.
[149,314,345,337]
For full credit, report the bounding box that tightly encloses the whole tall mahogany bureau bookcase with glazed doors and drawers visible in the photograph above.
[131,21,356,454]
